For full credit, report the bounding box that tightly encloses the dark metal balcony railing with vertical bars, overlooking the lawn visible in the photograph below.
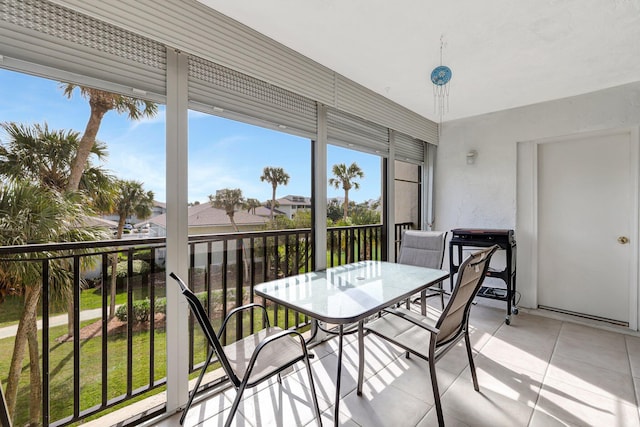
[0,224,411,426]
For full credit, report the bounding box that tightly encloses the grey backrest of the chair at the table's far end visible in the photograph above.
[398,230,447,268]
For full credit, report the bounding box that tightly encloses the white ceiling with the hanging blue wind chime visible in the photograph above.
[199,0,640,121]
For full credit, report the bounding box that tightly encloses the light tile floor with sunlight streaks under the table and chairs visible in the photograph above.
[142,299,640,427]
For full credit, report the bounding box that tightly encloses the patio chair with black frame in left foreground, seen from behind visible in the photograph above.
[170,273,322,427]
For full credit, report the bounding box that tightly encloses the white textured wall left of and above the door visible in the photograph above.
[434,82,640,307]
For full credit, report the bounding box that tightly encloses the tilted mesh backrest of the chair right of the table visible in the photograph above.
[436,245,498,346]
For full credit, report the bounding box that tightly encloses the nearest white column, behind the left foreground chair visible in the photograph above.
[166,48,189,413]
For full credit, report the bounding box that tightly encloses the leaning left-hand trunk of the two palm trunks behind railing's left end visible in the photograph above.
[6,283,42,418]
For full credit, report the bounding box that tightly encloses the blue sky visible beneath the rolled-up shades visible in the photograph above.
[0,69,381,202]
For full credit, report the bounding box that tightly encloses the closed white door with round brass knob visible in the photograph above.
[538,132,638,324]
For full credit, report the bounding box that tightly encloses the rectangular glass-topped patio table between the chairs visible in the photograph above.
[254,261,449,425]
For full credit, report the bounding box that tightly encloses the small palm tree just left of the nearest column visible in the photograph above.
[109,180,154,319]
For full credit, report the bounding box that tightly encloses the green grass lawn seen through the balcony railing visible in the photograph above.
[0,302,302,426]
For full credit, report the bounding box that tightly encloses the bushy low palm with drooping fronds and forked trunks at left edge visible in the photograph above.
[0,180,105,425]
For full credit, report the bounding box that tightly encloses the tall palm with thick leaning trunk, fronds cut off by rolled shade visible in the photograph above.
[61,83,158,191]
